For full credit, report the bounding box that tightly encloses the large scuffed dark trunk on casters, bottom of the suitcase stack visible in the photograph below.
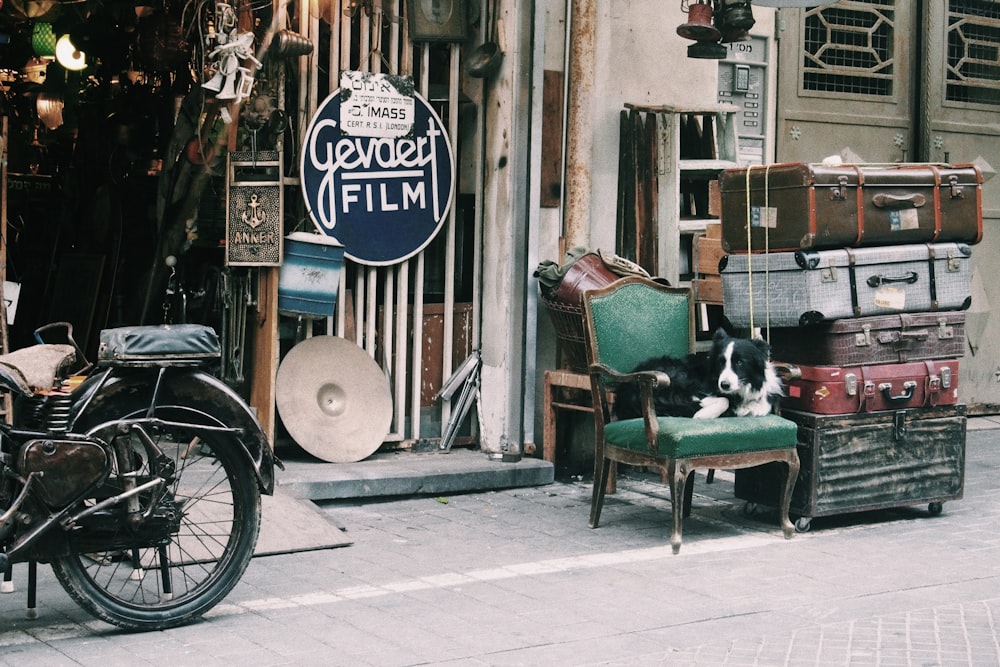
[735,405,966,530]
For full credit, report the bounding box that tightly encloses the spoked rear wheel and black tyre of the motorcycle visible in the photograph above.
[52,408,261,630]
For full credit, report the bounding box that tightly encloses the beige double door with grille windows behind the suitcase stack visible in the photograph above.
[776,0,1000,413]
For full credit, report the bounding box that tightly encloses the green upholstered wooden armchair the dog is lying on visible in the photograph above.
[583,277,799,553]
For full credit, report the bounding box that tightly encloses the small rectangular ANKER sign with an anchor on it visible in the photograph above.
[226,151,284,266]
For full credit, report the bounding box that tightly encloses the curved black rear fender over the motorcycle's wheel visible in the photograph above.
[71,367,280,495]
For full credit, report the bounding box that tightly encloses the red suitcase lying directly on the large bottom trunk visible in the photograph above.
[781,359,958,415]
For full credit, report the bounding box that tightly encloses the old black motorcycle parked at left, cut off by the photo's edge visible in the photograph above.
[0,323,280,630]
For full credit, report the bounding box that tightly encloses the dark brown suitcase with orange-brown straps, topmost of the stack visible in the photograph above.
[719,163,983,253]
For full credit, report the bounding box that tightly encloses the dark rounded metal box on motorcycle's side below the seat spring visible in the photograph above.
[18,438,111,508]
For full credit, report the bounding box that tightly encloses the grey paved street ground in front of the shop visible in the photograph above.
[0,420,1000,667]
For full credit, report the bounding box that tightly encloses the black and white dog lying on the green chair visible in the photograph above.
[615,329,783,419]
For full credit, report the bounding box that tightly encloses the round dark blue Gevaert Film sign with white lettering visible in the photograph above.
[300,88,455,266]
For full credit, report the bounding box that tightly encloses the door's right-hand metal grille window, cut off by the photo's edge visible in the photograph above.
[945,0,1000,106]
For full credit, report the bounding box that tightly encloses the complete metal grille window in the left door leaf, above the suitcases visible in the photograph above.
[802,0,895,97]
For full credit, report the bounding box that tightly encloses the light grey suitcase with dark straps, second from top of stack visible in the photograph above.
[719,243,972,327]
